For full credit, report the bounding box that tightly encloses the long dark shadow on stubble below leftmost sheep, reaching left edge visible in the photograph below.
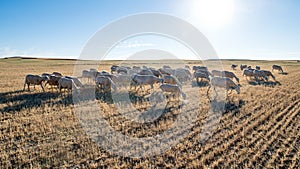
[0,88,113,113]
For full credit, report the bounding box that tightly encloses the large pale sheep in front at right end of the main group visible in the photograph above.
[207,77,241,99]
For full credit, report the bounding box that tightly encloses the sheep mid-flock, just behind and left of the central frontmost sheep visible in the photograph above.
[132,74,163,90]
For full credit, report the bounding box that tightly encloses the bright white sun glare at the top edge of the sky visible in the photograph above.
[190,0,234,27]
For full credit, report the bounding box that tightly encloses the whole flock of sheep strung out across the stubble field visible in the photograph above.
[23,64,283,99]
